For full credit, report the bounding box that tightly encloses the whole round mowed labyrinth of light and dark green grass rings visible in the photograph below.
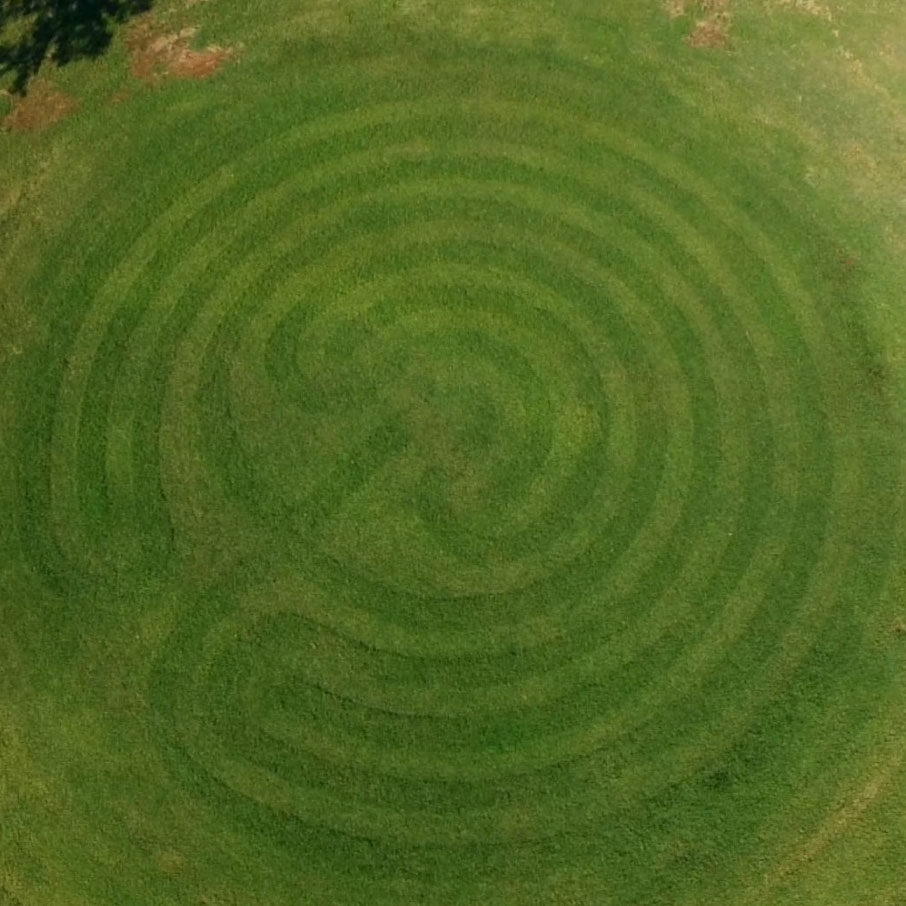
[8,38,900,900]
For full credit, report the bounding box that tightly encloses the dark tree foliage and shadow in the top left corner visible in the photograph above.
[0,0,154,95]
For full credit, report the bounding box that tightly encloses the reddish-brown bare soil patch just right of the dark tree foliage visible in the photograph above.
[126,17,234,83]
